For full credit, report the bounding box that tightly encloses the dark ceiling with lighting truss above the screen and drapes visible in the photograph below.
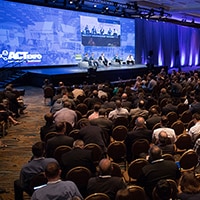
[5,0,200,28]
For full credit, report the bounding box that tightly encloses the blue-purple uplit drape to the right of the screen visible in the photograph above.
[135,19,200,67]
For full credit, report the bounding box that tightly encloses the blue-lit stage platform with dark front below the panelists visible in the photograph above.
[19,64,199,87]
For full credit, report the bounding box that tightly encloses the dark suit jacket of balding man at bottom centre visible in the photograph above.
[87,176,126,200]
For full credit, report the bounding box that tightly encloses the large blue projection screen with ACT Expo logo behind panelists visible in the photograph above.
[0,0,135,67]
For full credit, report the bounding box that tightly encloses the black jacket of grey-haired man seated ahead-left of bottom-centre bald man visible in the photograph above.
[61,148,96,178]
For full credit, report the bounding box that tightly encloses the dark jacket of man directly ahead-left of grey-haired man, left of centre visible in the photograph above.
[46,134,74,158]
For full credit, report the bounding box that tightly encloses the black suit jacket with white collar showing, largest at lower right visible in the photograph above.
[137,159,181,199]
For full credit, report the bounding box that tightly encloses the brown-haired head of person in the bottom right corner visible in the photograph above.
[180,171,200,194]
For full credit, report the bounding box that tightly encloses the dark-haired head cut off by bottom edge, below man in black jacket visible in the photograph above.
[155,179,172,200]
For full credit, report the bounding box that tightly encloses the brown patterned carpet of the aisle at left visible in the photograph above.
[0,86,50,200]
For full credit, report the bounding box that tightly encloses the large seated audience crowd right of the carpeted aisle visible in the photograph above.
[1,69,200,200]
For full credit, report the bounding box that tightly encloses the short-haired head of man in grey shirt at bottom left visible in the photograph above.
[45,162,61,180]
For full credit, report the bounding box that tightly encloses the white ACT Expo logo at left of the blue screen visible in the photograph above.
[0,50,42,63]
